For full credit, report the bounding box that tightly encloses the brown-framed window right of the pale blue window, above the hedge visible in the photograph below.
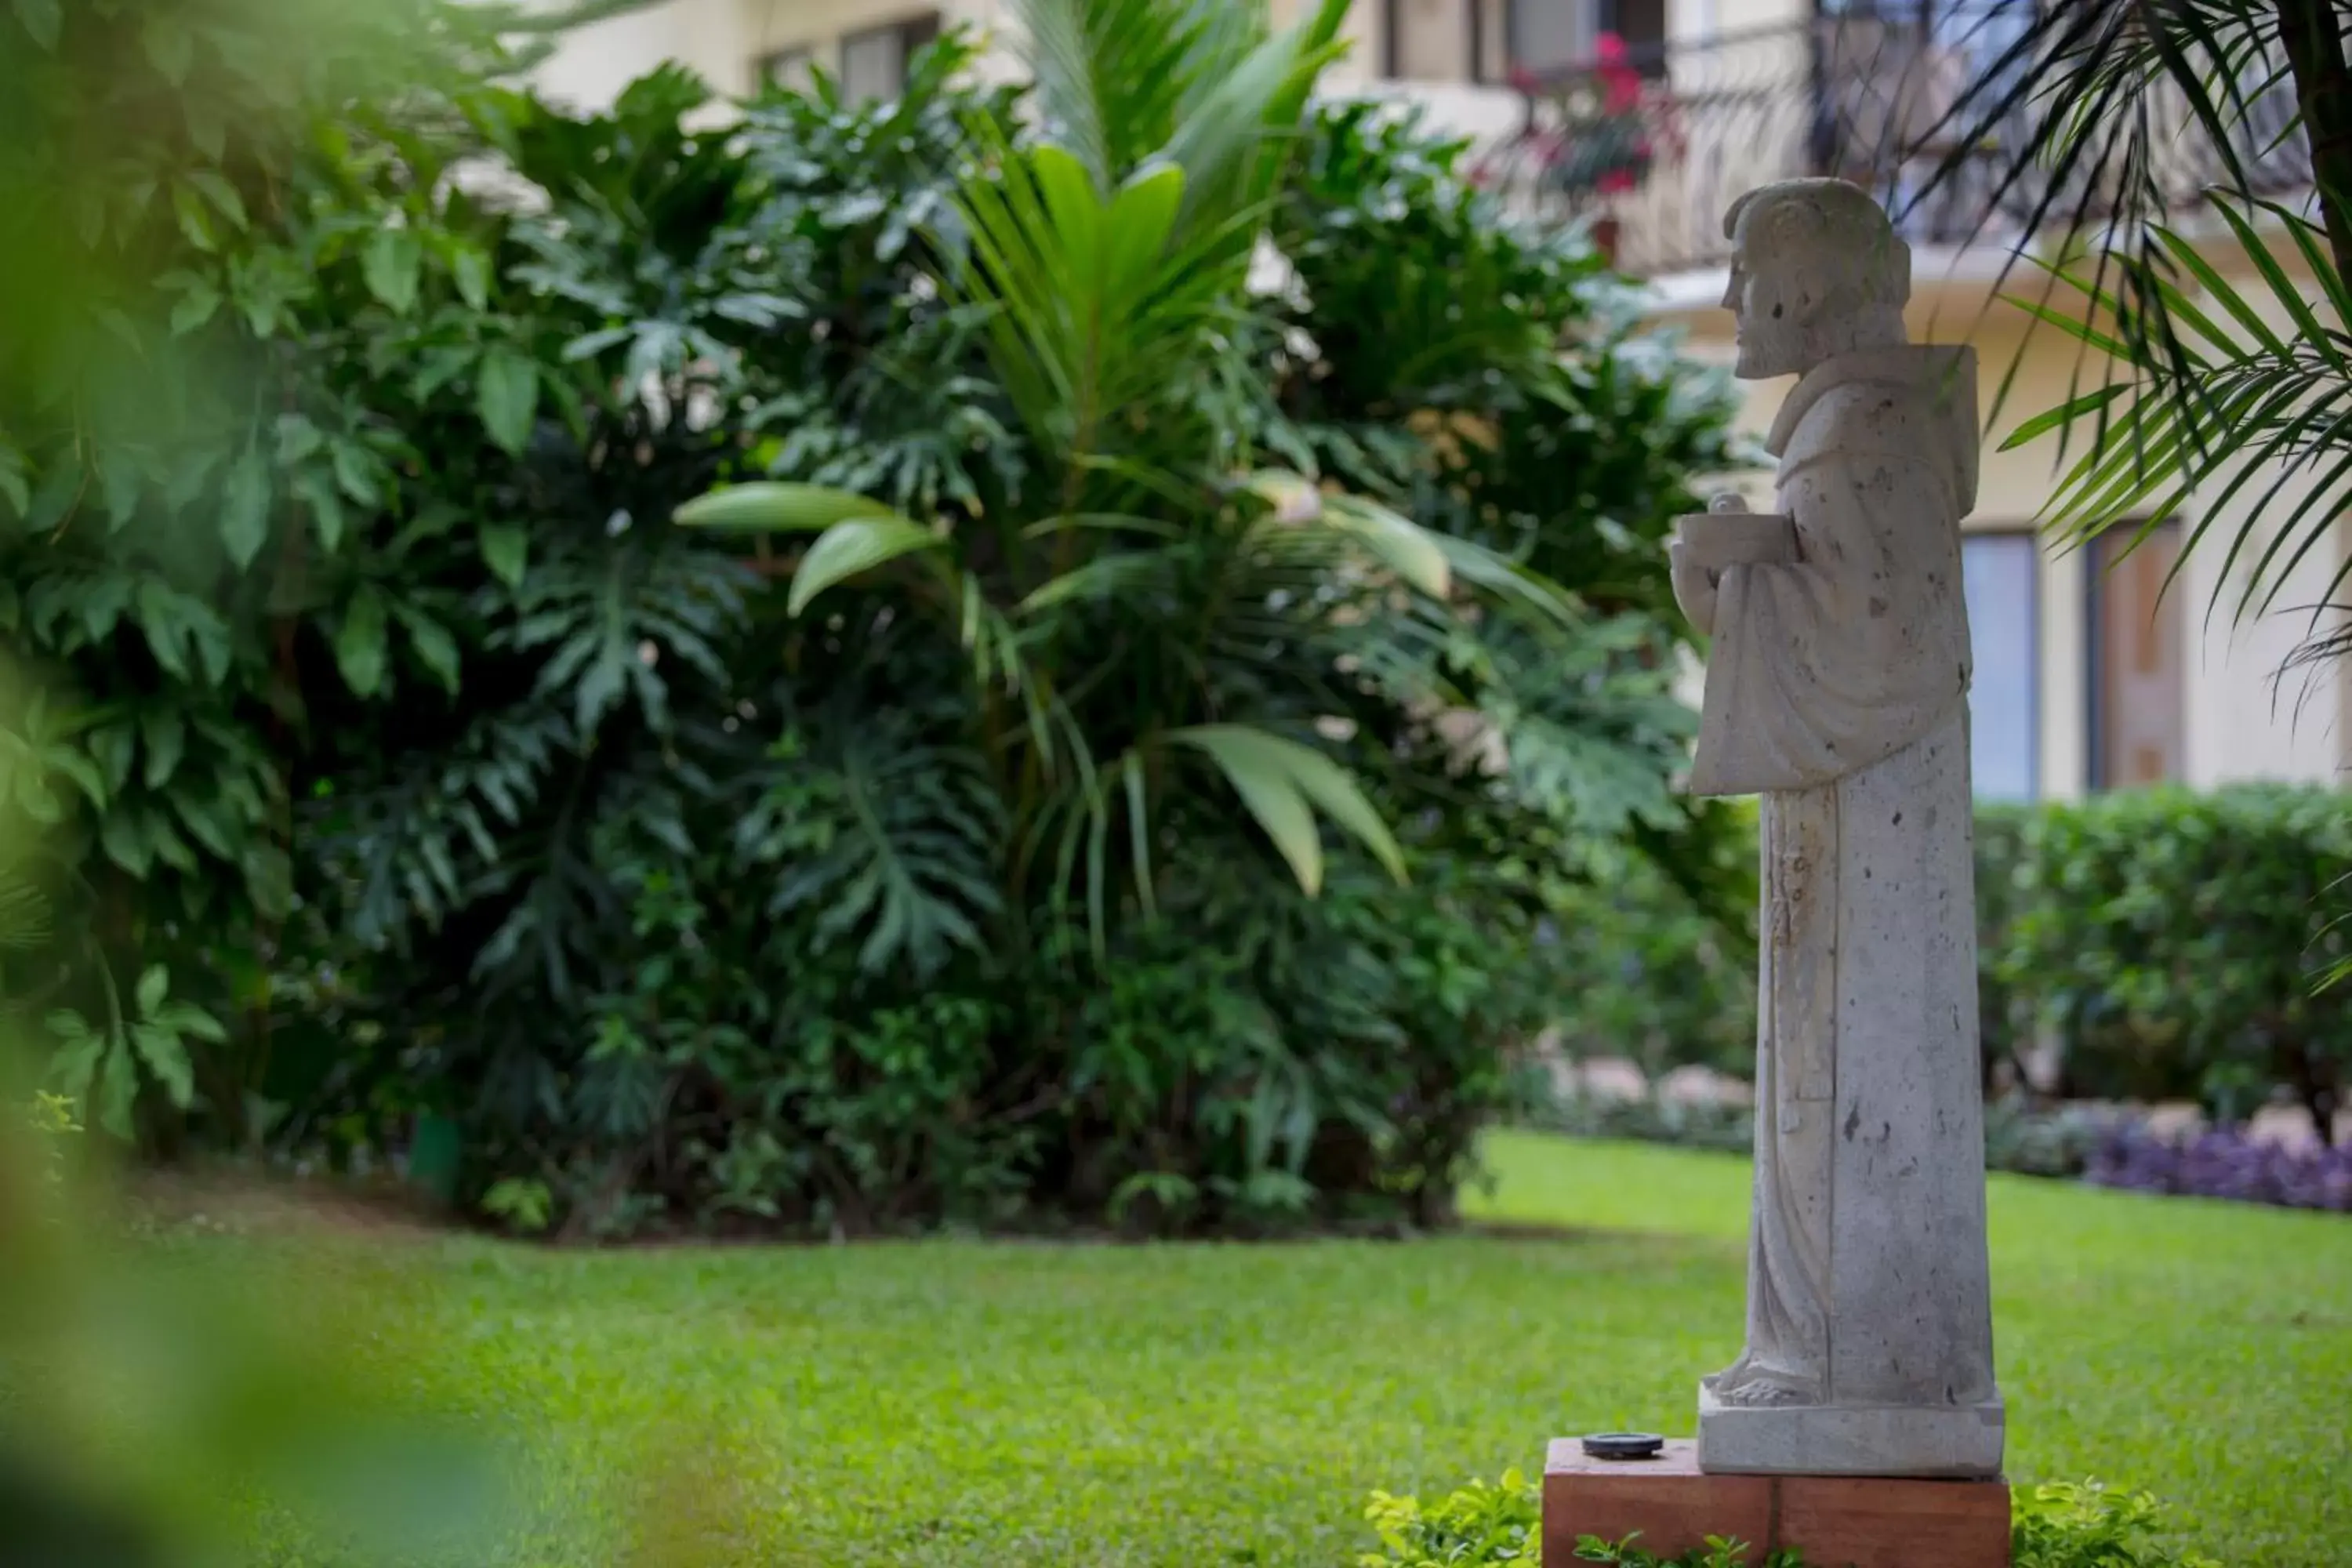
[2089,522,2187,789]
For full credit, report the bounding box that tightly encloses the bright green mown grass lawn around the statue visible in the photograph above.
[327,1135,2352,1568]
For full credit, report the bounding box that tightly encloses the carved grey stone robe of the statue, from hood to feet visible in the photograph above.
[1691,346,1997,1406]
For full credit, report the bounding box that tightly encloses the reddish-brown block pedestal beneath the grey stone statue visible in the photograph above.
[1543,1439,2009,1568]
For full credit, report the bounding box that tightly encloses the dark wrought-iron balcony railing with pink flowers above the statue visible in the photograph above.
[1479,7,2312,278]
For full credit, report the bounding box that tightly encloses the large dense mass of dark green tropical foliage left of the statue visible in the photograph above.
[0,0,1752,1236]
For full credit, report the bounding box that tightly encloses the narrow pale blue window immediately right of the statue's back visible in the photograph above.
[1959,534,2042,799]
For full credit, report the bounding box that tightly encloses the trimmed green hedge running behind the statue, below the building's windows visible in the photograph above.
[1562,785,2352,1142]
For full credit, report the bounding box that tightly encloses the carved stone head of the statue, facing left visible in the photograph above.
[1724,179,1910,381]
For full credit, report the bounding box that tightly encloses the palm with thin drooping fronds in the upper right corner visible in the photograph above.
[1912,0,2352,661]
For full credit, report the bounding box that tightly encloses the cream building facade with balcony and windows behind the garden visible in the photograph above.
[541,0,2352,799]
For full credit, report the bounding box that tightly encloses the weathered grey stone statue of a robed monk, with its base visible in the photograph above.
[1670,179,2002,1476]
